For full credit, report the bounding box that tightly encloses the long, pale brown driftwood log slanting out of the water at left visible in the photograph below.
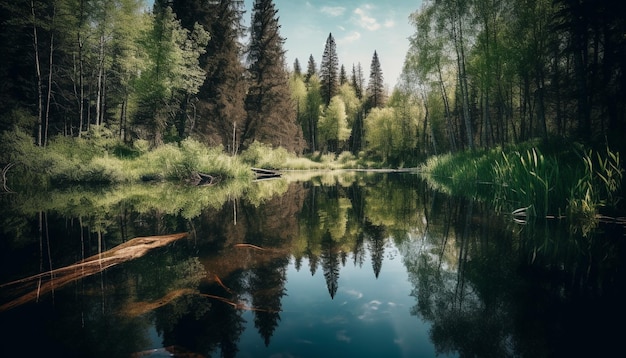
[0,233,187,312]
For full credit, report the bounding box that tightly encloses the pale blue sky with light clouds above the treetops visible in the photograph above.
[244,0,421,91]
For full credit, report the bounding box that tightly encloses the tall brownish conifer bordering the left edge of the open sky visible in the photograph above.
[242,0,304,152]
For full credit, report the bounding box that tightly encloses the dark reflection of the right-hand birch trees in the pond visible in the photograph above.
[404,190,626,357]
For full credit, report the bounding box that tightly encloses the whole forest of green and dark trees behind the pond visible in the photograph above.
[0,0,626,174]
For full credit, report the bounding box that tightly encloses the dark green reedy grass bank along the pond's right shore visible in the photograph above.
[420,141,624,218]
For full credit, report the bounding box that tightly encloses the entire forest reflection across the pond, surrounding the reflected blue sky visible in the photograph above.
[0,175,626,357]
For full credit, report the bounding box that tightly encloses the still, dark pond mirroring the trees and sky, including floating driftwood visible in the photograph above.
[0,172,626,357]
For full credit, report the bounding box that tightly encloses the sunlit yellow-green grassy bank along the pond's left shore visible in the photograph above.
[0,126,377,188]
